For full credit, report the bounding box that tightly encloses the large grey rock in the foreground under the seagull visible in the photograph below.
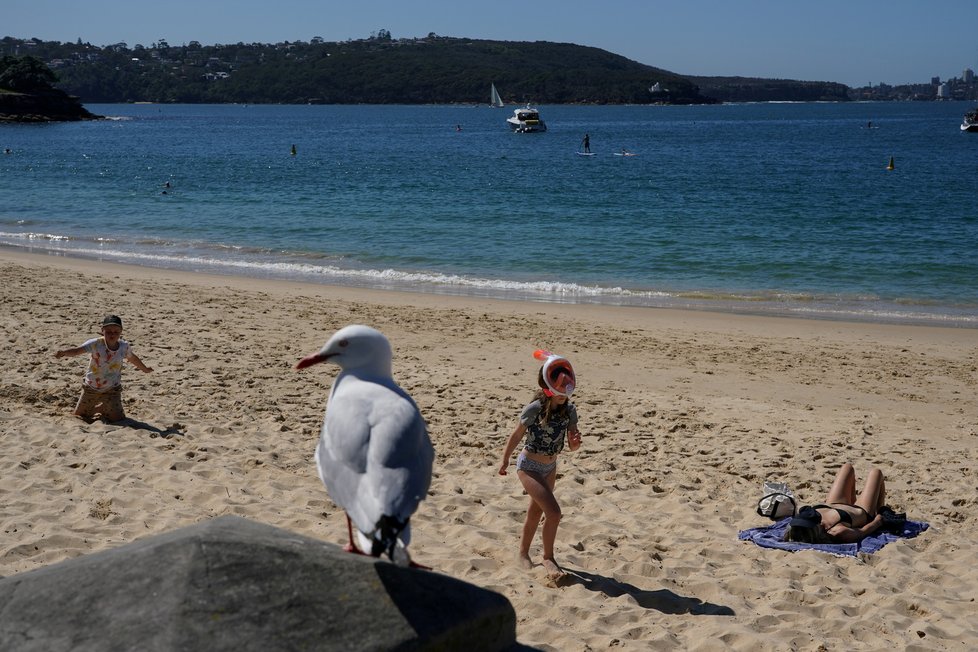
[0,516,516,652]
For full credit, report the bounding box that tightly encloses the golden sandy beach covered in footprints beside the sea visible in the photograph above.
[0,250,978,650]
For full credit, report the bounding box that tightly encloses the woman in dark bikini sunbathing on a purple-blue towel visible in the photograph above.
[785,462,889,543]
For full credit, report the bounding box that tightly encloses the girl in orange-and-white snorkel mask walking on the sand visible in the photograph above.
[499,350,581,578]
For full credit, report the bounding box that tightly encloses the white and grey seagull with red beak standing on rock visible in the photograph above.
[296,325,435,568]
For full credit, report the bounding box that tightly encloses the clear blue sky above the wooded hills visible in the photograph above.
[7,0,978,87]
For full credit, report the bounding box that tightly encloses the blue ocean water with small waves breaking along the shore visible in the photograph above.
[0,103,978,327]
